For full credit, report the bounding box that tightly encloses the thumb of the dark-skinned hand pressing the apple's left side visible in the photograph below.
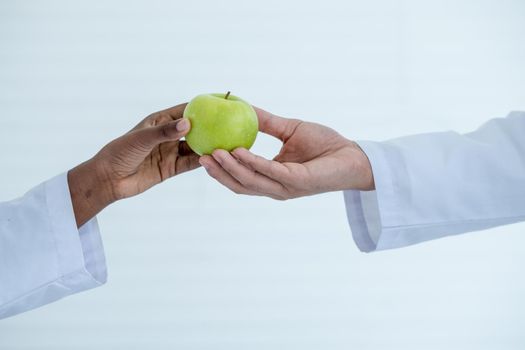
[126,118,191,153]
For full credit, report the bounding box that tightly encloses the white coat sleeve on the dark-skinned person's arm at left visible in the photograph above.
[0,174,106,319]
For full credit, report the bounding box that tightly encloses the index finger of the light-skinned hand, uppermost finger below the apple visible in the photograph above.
[232,148,290,183]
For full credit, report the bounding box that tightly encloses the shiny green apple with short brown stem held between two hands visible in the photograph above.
[184,91,259,155]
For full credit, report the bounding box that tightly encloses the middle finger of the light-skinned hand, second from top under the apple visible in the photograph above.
[212,150,286,198]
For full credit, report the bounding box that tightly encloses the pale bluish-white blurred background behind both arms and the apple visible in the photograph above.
[0,0,525,350]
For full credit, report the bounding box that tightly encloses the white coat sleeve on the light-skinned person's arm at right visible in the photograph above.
[344,112,525,252]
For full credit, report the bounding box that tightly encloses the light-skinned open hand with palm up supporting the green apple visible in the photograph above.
[199,108,374,200]
